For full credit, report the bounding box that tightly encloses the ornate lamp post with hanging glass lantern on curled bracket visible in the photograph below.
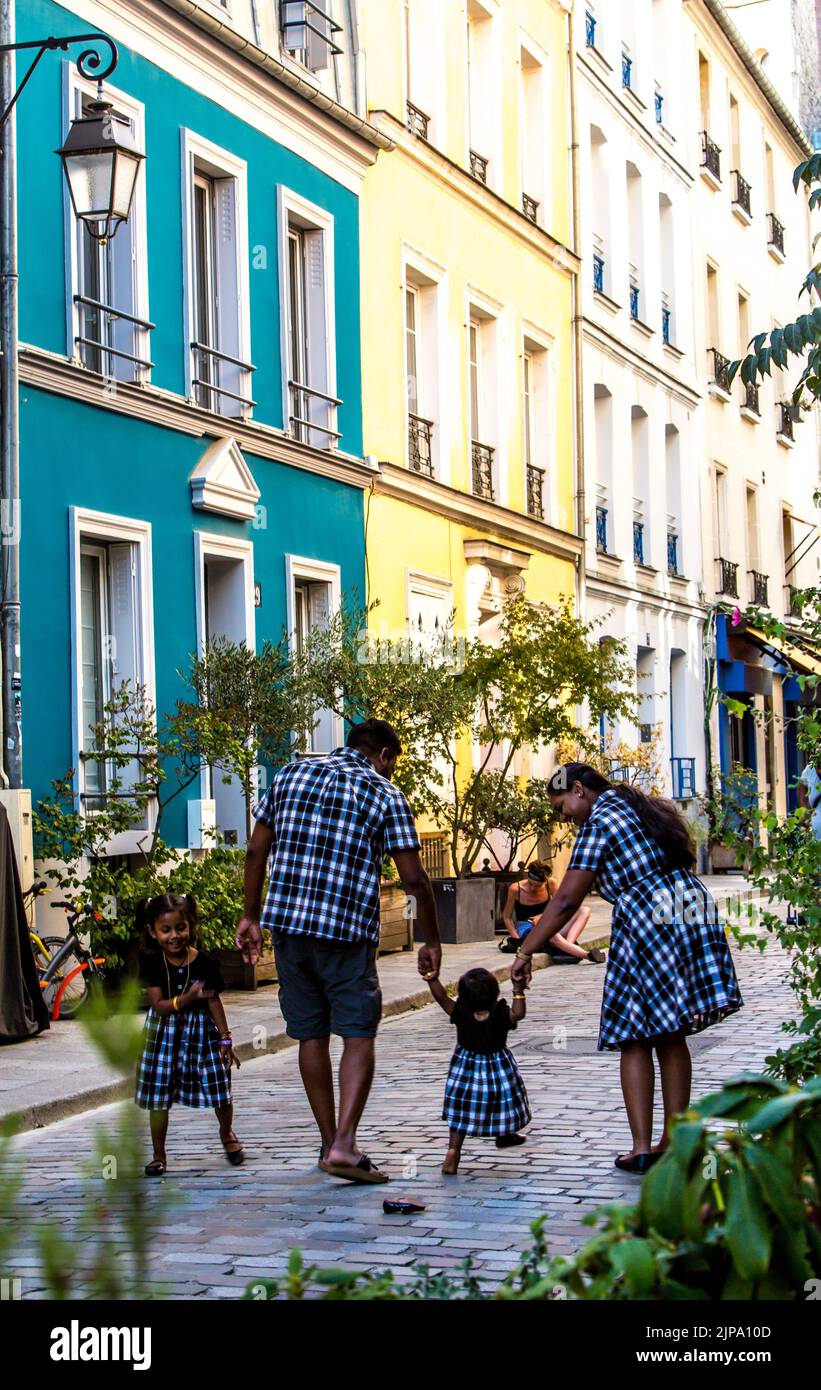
[0,21,144,790]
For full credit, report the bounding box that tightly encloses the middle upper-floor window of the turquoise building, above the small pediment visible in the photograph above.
[182,131,256,417]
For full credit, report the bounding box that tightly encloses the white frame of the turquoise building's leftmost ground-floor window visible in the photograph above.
[68,506,157,855]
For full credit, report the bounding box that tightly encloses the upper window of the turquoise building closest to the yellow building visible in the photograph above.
[279,188,342,449]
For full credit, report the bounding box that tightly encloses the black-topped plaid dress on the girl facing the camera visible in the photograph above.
[135,951,231,1111]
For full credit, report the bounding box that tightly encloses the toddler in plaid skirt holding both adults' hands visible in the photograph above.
[425,969,531,1175]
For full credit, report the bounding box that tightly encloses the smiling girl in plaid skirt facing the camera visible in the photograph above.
[135,892,243,1177]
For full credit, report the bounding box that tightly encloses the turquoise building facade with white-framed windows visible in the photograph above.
[17,0,386,852]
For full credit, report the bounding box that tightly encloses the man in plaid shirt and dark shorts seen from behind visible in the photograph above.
[236,719,442,1183]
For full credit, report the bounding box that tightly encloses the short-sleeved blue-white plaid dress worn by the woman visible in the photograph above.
[568,791,743,1051]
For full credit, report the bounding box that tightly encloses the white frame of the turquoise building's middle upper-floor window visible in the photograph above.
[181,128,253,420]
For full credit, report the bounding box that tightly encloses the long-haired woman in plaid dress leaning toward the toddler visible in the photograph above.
[511,763,743,1173]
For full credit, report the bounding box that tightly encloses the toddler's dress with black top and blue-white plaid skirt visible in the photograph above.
[442,999,531,1136]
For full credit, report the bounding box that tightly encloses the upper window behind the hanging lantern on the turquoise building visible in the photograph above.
[65,78,154,382]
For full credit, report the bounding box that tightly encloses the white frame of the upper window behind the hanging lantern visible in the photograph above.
[63,61,151,385]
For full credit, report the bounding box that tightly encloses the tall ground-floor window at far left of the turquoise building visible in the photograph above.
[71,507,154,811]
